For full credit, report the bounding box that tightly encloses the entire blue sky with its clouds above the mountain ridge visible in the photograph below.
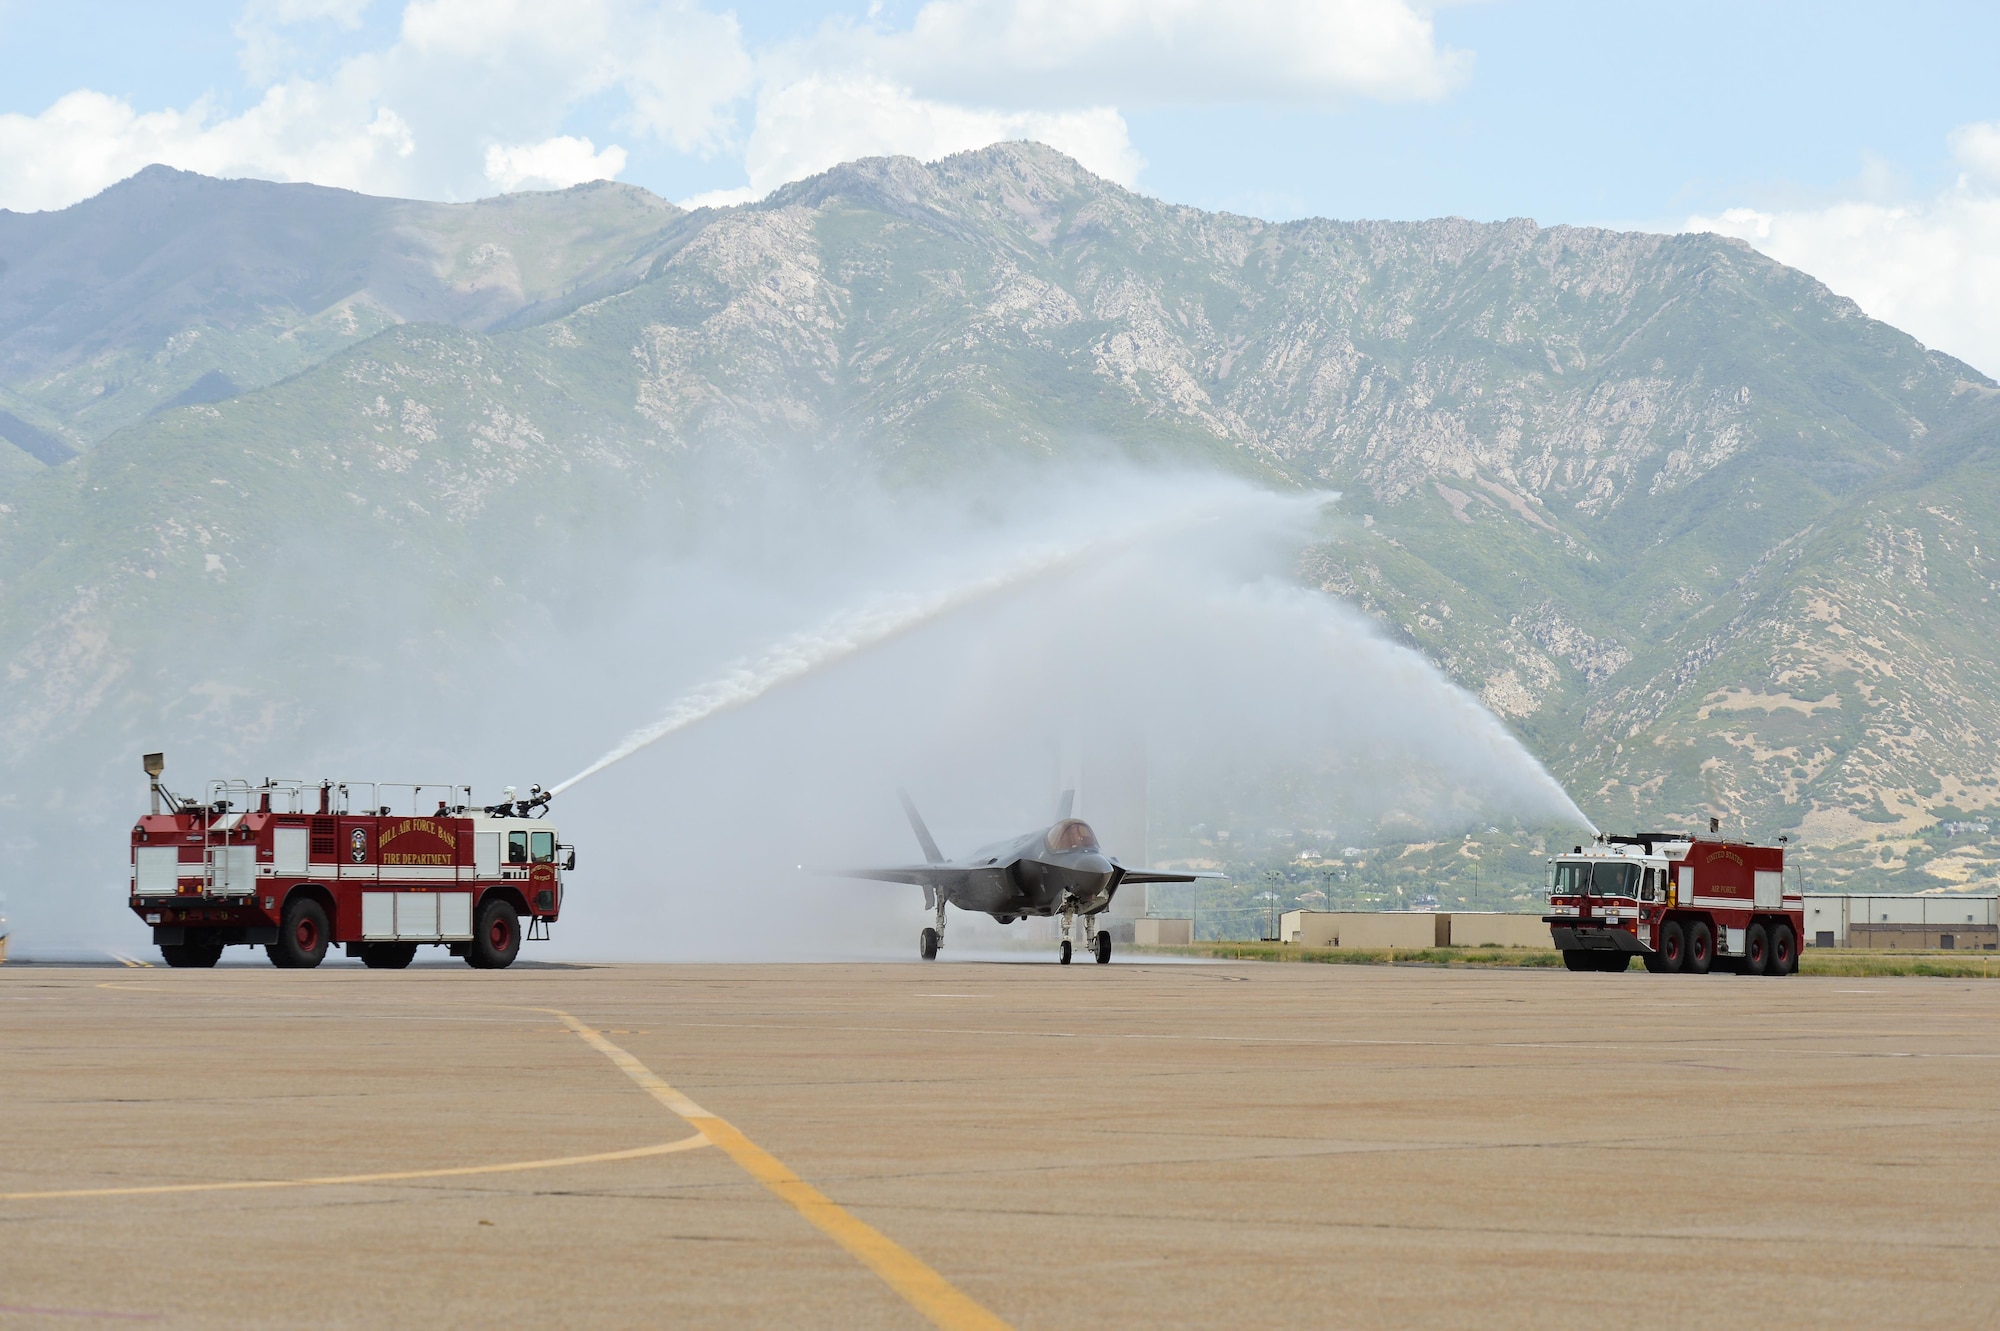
[0,0,2000,372]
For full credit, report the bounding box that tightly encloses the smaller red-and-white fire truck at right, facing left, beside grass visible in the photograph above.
[1542,823,1806,975]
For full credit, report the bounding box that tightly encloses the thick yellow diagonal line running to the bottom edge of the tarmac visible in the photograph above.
[536,1007,1006,1331]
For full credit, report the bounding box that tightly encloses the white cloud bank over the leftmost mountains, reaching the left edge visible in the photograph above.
[0,0,754,208]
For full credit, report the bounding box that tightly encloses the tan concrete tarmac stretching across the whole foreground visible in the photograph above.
[0,953,2000,1329]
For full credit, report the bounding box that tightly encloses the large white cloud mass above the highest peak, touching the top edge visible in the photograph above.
[688,0,1468,206]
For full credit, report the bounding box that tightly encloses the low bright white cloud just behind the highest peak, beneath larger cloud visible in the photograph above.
[732,76,1142,202]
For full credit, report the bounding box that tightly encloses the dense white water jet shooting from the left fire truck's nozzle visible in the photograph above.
[550,496,1296,795]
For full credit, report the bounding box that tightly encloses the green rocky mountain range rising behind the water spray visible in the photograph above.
[0,144,2000,889]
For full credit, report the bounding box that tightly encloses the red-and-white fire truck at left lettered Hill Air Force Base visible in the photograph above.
[132,753,576,969]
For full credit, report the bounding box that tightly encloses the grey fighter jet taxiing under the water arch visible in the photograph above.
[842,789,1220,965]
